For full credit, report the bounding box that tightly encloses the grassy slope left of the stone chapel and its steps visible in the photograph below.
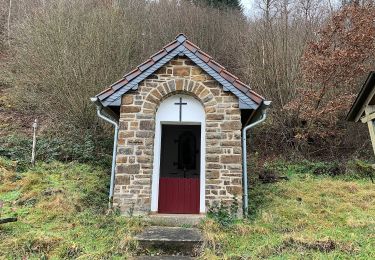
[0,159,142,259]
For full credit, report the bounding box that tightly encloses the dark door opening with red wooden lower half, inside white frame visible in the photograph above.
[158,125,200,214]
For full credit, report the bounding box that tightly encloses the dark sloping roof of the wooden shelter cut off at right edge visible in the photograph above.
[346,71,375,122]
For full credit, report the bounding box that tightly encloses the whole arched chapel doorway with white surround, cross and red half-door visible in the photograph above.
[151,94,205,214]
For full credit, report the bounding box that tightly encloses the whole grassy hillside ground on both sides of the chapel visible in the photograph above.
[0,159,375,259]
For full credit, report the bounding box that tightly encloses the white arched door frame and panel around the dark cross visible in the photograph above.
[151,94,206,213]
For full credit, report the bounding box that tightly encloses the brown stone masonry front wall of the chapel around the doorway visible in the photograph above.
[114,57,242,214]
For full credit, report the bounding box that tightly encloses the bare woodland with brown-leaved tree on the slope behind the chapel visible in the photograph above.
[0,0,375,161]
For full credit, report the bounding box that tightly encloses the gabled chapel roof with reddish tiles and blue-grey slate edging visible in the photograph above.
[96,34,264,109]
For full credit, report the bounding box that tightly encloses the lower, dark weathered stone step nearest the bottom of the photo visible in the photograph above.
[135,226,203,259]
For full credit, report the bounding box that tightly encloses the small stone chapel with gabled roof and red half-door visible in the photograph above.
[91,34,270,215]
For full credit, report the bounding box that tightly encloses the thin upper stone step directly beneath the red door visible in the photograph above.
[148,214,205,227]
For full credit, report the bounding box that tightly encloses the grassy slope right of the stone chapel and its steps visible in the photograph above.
[203,162,375,259]
